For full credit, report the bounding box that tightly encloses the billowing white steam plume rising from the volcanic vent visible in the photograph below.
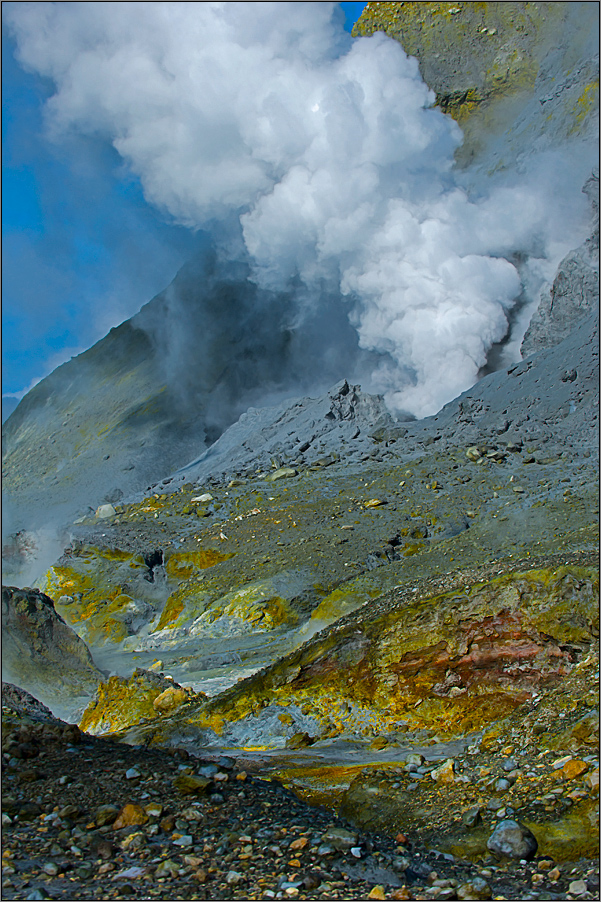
[7,2,586,416]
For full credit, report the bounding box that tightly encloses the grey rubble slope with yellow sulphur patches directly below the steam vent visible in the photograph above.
[23,308,598,708]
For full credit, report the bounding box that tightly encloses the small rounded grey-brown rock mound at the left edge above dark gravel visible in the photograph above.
[2,586,104,712]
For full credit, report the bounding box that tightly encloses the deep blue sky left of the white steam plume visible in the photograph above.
[2,3,365,419]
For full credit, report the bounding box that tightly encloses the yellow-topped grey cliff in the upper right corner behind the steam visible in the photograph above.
[353,0,599,171]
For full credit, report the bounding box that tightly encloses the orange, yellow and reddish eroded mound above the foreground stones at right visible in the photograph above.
[130,566,598,742]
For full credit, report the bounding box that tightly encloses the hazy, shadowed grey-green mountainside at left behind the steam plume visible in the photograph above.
[2,252,380,533]
